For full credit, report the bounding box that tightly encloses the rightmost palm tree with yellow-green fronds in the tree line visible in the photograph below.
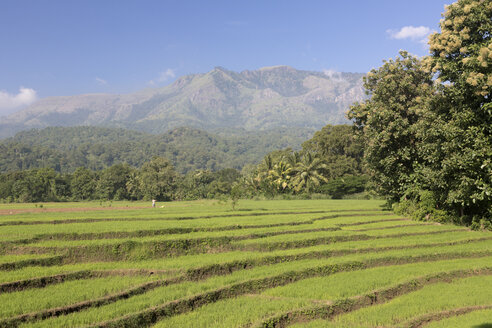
[293,153,328,192]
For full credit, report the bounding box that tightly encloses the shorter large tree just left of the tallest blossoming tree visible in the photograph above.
[348,51,435,202]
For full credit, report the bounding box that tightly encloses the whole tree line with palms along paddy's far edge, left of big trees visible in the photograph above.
[0,125,367,202]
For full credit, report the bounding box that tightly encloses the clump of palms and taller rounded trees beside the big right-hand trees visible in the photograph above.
[245,125,365,198]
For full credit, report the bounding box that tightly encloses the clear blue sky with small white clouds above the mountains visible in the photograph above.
[0,0,452,116]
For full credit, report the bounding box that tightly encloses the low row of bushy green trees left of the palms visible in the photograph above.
[0,157,243,202]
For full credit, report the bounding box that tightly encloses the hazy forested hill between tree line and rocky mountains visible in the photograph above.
[0,126,314,173]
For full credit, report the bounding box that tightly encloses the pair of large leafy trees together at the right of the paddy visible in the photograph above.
[349,0,492,227]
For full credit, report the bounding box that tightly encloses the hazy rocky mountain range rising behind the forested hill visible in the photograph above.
[0,66,365,138]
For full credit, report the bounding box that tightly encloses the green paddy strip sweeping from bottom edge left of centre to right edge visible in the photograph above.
[155,257,492,327]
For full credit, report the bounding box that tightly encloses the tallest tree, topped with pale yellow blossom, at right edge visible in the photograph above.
[421,0,492,223]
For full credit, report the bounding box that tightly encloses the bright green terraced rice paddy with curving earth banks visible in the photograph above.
[0,200,492,328]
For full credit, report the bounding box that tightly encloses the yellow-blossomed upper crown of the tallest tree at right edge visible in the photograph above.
[429,0,492,101]
